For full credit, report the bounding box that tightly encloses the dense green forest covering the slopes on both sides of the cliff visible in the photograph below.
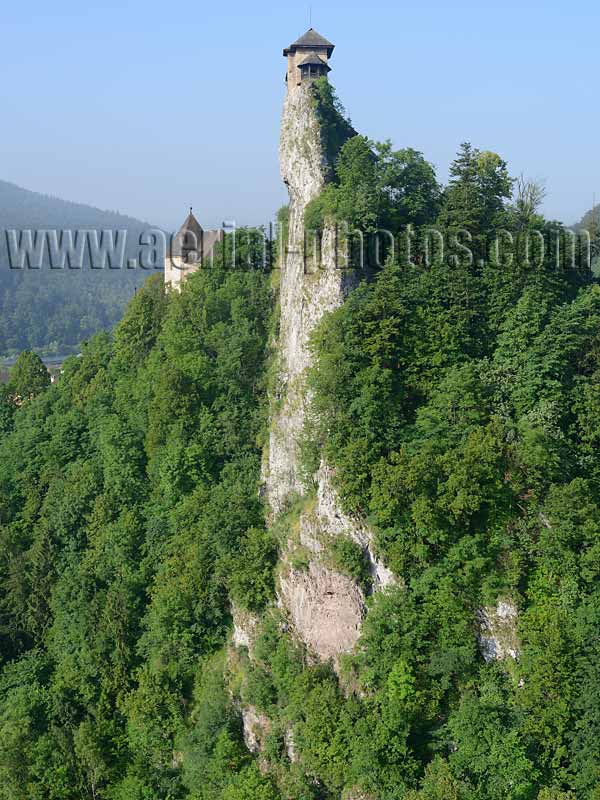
[0,84,600,800]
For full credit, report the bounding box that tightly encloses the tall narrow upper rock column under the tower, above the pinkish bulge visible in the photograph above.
[266,84,353,513]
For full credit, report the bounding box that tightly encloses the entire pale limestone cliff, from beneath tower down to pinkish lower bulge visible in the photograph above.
[265,84,393,663]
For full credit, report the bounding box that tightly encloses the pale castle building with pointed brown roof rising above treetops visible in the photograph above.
[165,208,224,291]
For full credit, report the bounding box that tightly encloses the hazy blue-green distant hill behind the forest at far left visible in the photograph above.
[0,181,162,355]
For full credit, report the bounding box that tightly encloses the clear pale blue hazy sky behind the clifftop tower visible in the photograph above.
[0,0,600,228]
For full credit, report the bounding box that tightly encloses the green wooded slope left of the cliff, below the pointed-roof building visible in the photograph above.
[0,230,275,799]
